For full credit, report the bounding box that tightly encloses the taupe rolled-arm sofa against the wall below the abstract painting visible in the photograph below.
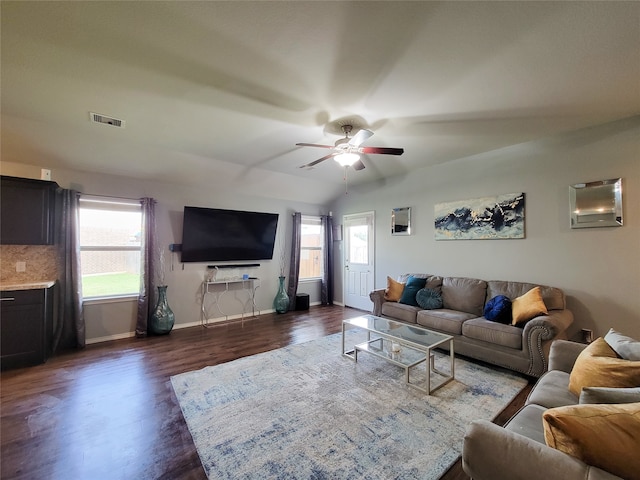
[369,273,573,377]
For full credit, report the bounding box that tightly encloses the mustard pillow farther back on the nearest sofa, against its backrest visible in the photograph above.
[569,337,640,397]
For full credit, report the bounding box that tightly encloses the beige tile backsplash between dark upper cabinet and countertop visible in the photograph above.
[0,245,58,284]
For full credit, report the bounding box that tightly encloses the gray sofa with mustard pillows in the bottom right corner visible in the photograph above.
[462,330,640,480]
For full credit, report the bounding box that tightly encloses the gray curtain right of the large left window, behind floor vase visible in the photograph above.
[136,197,157,338]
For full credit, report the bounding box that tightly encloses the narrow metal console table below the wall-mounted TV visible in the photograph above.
[200,277,260,327]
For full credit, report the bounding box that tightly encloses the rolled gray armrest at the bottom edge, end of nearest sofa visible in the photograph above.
[462,420,618,480]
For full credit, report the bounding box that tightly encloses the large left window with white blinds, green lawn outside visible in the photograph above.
[80,197,142,298]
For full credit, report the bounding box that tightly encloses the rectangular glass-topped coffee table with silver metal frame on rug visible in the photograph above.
[342,315,455,395]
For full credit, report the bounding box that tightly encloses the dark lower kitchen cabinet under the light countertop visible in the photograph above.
[0,286,55,370]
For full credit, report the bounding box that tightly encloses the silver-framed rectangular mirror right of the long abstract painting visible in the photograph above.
[569,178,622,228]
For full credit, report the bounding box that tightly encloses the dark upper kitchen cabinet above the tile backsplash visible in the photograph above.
[0,175,58,245]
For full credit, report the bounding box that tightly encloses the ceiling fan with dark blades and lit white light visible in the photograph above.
[296,125,404,170]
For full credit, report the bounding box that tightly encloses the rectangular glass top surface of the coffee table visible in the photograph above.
[343,315,452,348]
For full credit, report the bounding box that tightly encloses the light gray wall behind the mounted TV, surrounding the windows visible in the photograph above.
[1,162,328,343]
